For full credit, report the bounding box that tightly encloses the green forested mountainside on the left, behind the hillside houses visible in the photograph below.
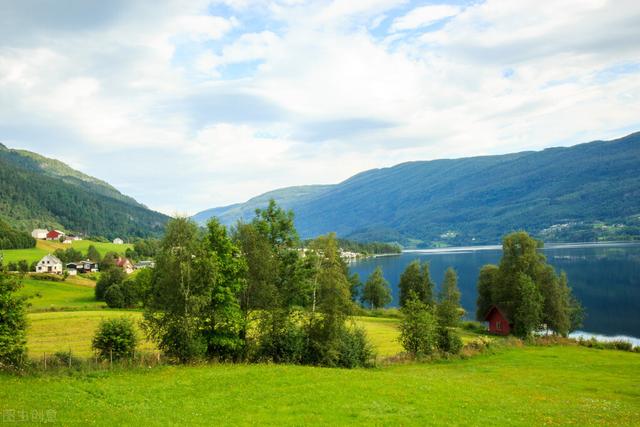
[0,144,168,239]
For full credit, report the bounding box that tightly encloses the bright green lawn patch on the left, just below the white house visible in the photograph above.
[20,277,105,311]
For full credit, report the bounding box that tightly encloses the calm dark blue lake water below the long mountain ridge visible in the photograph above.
[350,243,640,342]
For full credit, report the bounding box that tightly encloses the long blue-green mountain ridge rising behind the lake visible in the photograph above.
[194,132,640,247]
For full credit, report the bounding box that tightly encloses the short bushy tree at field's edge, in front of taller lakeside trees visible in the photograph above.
[399,291,437,357]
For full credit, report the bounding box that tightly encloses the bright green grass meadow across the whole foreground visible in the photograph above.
[0,346,640,426]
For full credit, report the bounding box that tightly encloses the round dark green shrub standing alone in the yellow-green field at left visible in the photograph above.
[92,318,138,360]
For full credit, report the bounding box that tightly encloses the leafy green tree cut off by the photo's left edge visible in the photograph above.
[0,266,27,368]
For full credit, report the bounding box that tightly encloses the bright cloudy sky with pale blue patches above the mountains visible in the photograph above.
[0,0,640,214]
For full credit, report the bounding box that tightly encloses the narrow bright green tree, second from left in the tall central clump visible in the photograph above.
[204,218,247,360]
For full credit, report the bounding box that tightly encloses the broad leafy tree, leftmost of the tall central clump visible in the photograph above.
[143,217,215,363]
